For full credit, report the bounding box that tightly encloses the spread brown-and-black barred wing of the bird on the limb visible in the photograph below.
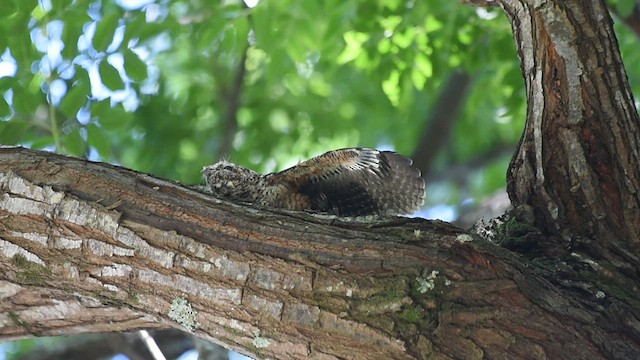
[274,148,424,216]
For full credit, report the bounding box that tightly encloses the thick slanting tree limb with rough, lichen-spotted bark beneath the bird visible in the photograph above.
[0,148,640,359]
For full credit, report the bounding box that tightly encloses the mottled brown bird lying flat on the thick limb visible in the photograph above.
[202,148,425,217]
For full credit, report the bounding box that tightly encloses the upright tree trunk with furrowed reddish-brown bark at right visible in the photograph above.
[500,0,640,258]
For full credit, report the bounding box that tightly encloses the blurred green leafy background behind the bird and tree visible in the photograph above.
[0,0,640,356]
